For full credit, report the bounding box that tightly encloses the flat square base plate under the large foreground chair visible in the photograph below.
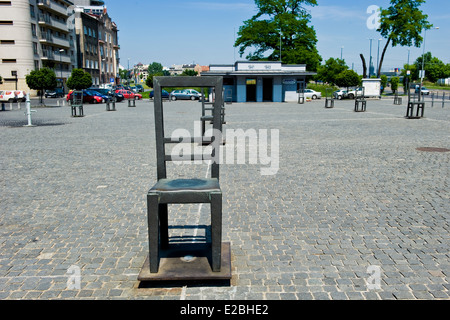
[138,242,231,281]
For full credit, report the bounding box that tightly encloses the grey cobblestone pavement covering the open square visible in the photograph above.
[0,100,450,300]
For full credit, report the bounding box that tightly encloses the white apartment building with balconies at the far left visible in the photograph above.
[0,0,76,90]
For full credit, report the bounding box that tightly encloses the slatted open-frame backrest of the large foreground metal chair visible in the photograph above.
[153,77,223,180]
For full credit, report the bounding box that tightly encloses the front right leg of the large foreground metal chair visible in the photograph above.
[211,193,222,272]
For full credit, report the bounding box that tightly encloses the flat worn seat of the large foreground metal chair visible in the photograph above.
[150,178,220,192]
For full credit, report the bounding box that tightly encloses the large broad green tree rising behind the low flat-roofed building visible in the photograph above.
[234,0,322,71]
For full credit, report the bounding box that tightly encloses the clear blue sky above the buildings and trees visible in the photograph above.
[105,0,450,73]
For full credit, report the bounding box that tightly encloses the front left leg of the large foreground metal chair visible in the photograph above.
[147,194,159,273]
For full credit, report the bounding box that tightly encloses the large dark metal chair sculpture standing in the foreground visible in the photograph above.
[147,77,223,274]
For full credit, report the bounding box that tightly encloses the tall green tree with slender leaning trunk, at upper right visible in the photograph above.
[377,0,433,77]
